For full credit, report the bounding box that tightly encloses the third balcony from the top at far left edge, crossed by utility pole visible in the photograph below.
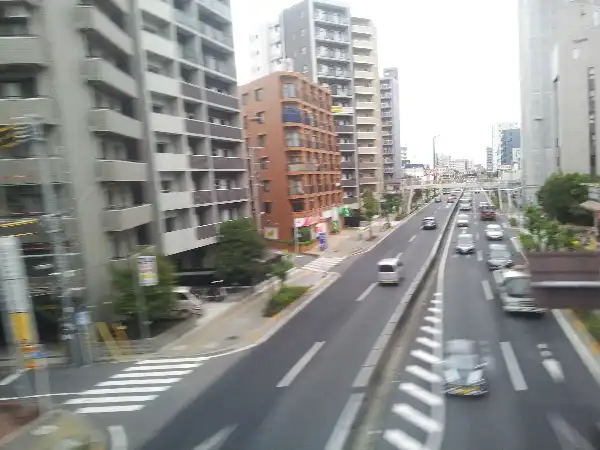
[0,158,69,186]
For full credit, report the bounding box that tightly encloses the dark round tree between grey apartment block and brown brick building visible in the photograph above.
[215,218,266,285]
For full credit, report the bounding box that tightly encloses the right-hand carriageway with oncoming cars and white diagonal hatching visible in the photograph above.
[377,195,600,450]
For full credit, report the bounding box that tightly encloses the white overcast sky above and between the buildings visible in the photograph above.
[231,0,520,163]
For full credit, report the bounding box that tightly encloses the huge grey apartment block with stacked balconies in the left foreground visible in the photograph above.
[0,0,248,303]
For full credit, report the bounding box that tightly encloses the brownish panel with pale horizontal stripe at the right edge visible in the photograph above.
[526,252,600,310]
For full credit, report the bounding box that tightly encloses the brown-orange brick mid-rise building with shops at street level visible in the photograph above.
[241,72,343,248]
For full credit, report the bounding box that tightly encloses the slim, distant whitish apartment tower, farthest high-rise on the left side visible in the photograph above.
[379,67,407,180]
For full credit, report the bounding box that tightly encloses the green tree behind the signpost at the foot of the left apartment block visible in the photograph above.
[111,252,177,320]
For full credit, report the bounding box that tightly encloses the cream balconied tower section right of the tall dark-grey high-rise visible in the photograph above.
[350,17,383,197]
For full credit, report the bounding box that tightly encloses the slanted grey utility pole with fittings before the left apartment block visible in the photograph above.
[23,116,91,366]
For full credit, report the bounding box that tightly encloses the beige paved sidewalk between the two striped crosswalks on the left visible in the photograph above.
[157,269,337,357]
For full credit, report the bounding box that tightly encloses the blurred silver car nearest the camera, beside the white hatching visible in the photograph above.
[444,339,488,396]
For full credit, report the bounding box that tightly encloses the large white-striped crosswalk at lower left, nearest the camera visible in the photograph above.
[64,357,206,414]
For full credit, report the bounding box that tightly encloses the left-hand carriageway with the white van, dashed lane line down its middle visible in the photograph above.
[143,203,452,450]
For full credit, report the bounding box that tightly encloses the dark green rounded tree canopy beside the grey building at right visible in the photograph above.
[537,173,593,225]
